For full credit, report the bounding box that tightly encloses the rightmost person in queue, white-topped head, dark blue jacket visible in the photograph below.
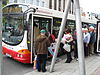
[89,26,96,55]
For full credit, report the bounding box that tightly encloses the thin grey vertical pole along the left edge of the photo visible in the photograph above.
[0,0,3,75]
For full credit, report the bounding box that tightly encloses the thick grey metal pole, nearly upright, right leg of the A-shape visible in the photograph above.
[74,0,86,75]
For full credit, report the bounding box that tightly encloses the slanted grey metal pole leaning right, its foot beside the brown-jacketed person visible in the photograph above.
[50,0,71,72]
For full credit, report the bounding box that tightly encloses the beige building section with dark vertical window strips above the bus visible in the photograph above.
[45,0,74,14]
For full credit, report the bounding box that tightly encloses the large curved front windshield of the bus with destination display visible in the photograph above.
[2,5,28,45]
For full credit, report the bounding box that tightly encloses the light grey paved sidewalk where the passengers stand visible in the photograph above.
[24,55,100,75]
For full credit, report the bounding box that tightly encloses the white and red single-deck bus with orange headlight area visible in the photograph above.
[2,3,96,63]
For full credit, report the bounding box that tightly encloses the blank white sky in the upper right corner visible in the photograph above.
[79,0,100,14]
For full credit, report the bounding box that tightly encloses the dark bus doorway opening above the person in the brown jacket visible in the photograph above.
[33,16,53,56]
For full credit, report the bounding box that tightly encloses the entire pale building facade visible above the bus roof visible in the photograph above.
[9,0,74,14]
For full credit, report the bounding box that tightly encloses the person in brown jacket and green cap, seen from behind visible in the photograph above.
[35,29,50,72]
